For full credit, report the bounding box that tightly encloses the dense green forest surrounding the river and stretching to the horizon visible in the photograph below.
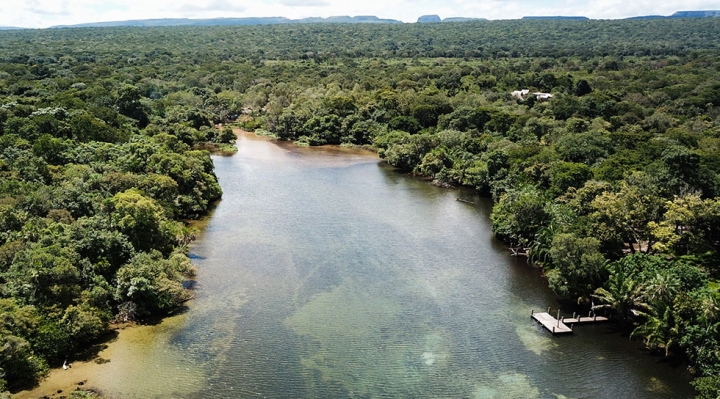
[0,19,720,398]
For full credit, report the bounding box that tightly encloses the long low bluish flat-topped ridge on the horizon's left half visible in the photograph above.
[51,15,403,28]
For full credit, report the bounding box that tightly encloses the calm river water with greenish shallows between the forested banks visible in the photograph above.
[16,135,692,398]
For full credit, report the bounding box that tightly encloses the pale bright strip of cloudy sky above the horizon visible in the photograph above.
[0,0,720,28]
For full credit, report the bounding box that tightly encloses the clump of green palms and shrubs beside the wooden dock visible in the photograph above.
[594,254,720,375]
